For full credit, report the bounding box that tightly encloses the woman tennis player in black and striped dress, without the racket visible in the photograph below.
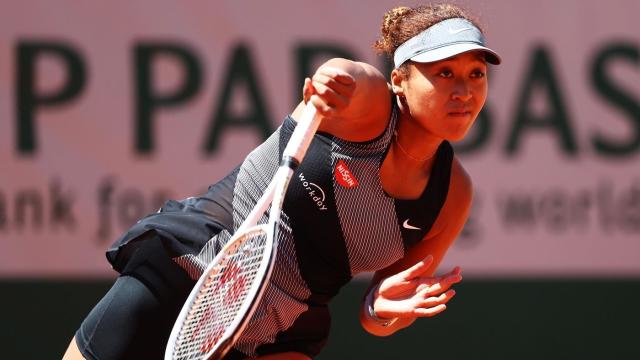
[65,5,500,360]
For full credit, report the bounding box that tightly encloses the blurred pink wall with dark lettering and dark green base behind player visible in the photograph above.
[0,0,640,359]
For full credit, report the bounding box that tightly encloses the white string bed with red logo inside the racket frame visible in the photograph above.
[173,231,267,360]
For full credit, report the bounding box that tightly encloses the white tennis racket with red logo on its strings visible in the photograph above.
[165,104,320,360]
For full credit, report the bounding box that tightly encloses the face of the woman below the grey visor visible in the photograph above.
[392,51,488,141]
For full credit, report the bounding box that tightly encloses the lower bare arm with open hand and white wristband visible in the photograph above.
[360,158,472,336]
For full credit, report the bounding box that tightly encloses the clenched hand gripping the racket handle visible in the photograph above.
[302,66,356,117]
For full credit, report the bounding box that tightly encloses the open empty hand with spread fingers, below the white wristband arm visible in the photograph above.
[373,255,462,319]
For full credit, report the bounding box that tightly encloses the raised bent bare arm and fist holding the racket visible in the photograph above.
[292,58,391,141]
